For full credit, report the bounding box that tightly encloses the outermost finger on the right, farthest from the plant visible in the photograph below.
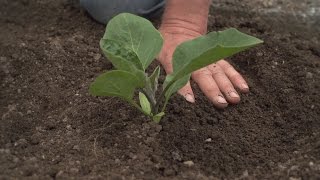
[216,60,249,93]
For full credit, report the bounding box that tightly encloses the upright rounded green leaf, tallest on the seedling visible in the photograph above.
[102,13,163,71]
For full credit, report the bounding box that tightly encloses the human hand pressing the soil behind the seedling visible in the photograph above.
[158,27,249,108]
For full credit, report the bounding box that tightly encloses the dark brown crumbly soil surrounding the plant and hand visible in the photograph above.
[0,0,320,179]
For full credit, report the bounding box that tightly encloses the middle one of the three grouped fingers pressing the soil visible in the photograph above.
[208,64,240,104]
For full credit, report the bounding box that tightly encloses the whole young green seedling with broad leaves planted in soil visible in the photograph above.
[89,13,263,122]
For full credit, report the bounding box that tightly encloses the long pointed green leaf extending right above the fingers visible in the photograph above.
[172,28,263,81]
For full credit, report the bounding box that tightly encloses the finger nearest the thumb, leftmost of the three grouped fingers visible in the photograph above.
[192,68,228,108]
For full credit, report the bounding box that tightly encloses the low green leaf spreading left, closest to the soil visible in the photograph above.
[89,70,144,102]
